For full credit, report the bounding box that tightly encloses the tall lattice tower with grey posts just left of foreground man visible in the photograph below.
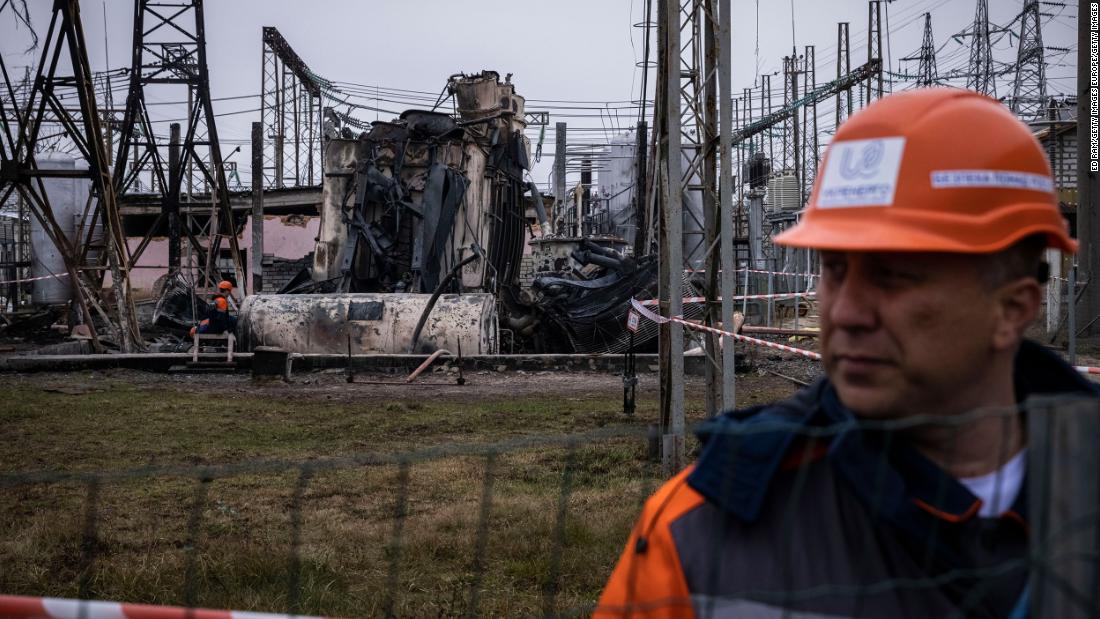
[647,0,736,472]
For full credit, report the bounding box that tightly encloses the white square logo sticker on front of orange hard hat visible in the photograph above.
[815,137,905,209]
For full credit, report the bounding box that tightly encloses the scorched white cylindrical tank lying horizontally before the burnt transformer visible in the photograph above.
[238,292,498,355]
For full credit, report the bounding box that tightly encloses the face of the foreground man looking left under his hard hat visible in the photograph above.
[817,252,997,418]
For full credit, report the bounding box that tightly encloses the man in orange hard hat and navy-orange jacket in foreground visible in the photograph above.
[595,88,1097,618]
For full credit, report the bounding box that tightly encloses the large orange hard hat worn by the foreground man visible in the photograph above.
[774,88,1077,254]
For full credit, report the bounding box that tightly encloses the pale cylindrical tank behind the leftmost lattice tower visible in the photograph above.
[31,154,91,305]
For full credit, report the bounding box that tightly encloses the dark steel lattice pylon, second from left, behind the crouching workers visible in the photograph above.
[114,0,248,289]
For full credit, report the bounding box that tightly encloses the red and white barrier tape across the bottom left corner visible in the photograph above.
[0,595,330,619]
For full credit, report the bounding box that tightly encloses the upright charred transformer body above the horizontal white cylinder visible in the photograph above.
[312,71,530,294]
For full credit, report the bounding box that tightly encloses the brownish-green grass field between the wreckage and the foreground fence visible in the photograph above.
[0,373,793,617]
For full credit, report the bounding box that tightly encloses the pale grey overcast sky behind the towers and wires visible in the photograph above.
[0,0,1077,190]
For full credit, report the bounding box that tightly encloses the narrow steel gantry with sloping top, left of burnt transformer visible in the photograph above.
[260,26,322,189]
